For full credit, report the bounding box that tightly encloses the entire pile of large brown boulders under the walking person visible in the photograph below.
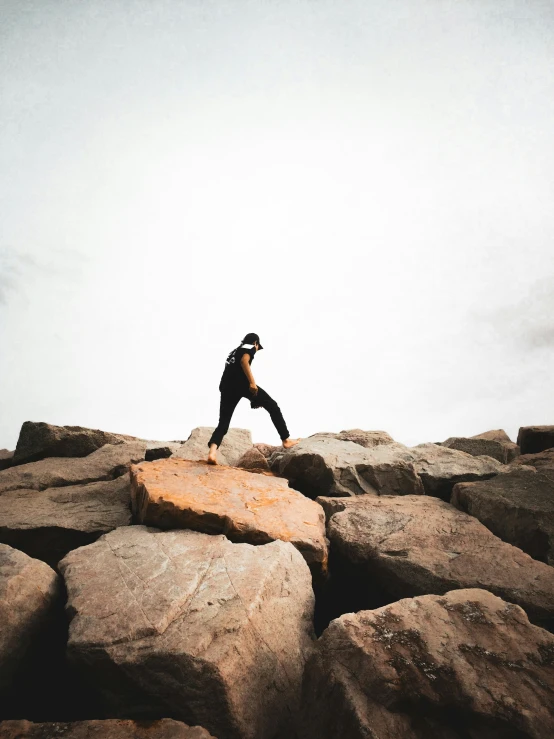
[0,422,554,739]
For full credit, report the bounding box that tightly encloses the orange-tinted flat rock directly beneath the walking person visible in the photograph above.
[131,458,327,569]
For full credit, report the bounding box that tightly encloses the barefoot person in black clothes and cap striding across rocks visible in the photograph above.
[208,334,300,464]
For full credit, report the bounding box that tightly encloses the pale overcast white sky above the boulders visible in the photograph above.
[0,0,554,449]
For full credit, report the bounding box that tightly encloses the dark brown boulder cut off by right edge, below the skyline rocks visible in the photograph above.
[452,470,554,565]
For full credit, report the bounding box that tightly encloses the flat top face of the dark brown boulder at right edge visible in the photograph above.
[454,469,554,512]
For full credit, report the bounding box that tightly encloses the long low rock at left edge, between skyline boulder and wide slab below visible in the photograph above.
[0,441,146,494]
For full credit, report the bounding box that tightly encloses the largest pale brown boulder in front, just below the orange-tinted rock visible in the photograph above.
[60,528,314,739]
